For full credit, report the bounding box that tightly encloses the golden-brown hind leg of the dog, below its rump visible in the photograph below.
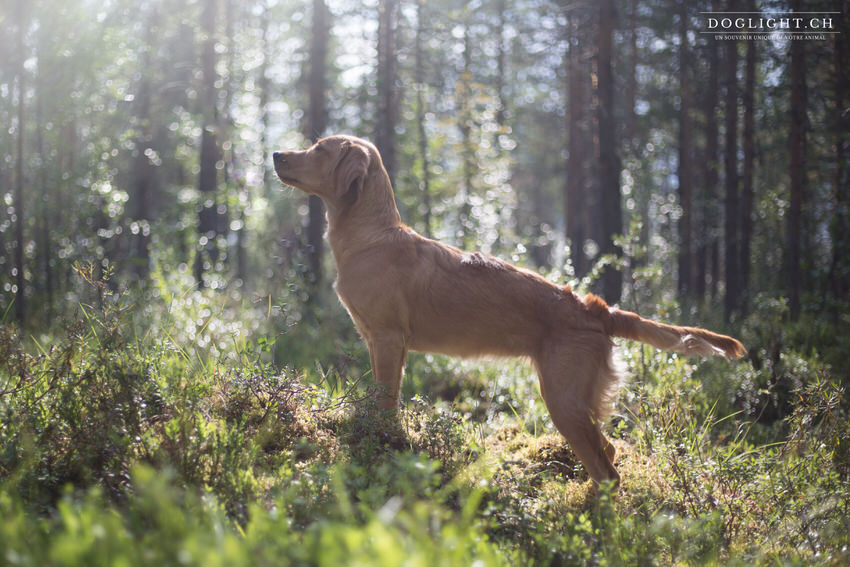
[535,335,620,486]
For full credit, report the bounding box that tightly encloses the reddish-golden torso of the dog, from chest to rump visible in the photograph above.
[337,229,604,357]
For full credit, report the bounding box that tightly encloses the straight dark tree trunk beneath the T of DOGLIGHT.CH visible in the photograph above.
[786,0,807,319]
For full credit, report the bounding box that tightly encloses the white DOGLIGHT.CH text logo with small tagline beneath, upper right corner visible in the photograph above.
[700,12,841,41]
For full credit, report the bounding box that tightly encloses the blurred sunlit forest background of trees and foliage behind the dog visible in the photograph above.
[0,0,850,350]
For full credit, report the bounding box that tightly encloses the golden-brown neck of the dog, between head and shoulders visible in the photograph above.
[325,171,402,264]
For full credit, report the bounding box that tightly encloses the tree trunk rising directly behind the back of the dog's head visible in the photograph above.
[375,0,398,186]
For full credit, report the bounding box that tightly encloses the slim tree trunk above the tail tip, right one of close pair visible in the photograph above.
[738,0,758,313]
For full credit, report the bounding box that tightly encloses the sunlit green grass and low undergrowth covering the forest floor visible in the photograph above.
[0,276,850,566]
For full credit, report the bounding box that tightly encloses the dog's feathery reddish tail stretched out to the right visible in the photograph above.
[585,296,747,359]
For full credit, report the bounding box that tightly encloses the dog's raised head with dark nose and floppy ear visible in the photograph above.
[273,136,372,208]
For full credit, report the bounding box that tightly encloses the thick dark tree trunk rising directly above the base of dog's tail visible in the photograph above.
[596,0,623,304]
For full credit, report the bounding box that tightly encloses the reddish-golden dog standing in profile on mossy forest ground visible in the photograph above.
[273,136,745,486]
